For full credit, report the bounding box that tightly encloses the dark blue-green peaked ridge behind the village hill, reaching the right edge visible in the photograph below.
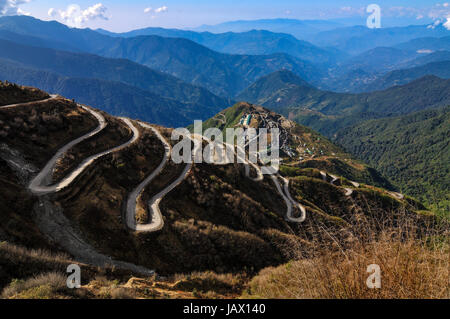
[239,75,450,136]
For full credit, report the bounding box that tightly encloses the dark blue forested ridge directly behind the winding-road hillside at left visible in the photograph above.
[0,40,232,126]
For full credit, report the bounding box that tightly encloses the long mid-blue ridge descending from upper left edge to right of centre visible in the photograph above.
[0,16,320,97]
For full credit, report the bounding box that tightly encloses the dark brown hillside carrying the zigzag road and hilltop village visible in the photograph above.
[0,84,436,296]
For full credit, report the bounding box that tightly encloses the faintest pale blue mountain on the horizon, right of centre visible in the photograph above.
[189,19,342,40]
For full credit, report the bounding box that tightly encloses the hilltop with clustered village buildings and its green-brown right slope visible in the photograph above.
[200,103,393,189]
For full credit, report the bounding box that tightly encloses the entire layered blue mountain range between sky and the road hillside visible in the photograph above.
[0,16,449,134]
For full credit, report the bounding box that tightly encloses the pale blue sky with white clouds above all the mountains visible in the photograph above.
[0,0,450,32]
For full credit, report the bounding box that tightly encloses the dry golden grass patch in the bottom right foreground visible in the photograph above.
[244,231,450,299]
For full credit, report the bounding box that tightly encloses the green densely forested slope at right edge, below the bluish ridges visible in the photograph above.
[335,106,450,215]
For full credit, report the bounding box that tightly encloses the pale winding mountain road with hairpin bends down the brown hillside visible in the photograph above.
[1,95,404,232]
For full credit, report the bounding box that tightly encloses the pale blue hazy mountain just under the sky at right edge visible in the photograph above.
[311,25,450,54]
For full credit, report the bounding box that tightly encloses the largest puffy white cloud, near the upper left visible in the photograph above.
[49,0,109,28]
